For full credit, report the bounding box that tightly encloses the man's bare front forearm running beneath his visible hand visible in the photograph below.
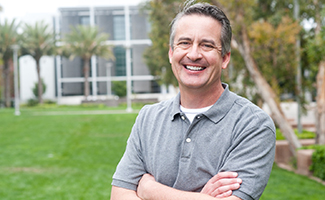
[137,174,240,200]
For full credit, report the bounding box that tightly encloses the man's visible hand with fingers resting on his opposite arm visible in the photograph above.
[201,172,242,198]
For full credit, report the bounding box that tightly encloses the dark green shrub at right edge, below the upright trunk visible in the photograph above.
[310,145,325,180]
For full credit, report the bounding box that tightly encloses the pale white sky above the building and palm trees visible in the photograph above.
[0,0,145,22]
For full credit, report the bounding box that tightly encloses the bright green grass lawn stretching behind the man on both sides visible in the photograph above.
[0,107,325,200]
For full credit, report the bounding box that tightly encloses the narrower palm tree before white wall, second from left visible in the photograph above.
[21,21,55,104]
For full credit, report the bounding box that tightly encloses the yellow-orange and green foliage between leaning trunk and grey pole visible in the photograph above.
[248,16,301,99]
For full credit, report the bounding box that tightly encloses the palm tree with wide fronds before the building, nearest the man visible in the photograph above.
[61,25,114,99]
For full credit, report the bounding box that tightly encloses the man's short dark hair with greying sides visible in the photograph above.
[169,0,232,57]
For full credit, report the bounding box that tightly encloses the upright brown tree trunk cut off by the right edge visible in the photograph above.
[316,61,325,144]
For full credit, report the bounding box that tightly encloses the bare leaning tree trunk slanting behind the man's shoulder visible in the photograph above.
[237,18,301,155]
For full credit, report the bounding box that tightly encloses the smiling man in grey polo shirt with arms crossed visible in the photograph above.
[111,0,275,200]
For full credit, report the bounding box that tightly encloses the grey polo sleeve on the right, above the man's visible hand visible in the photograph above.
[221,111,275,200]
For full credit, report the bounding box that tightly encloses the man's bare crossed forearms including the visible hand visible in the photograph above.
[111,172,242,200]
